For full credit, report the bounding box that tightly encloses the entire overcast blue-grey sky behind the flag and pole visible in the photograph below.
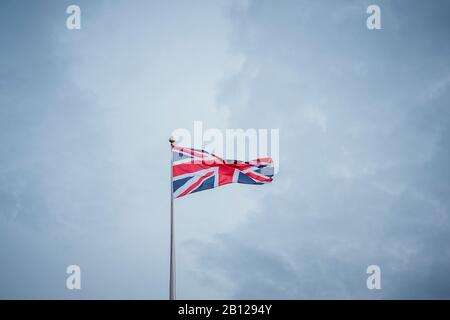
[0,0,450,299]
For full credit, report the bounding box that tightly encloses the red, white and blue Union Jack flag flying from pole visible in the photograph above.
[172,144,274,198]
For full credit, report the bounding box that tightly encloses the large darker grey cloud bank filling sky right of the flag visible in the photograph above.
[189,1,450,299]
